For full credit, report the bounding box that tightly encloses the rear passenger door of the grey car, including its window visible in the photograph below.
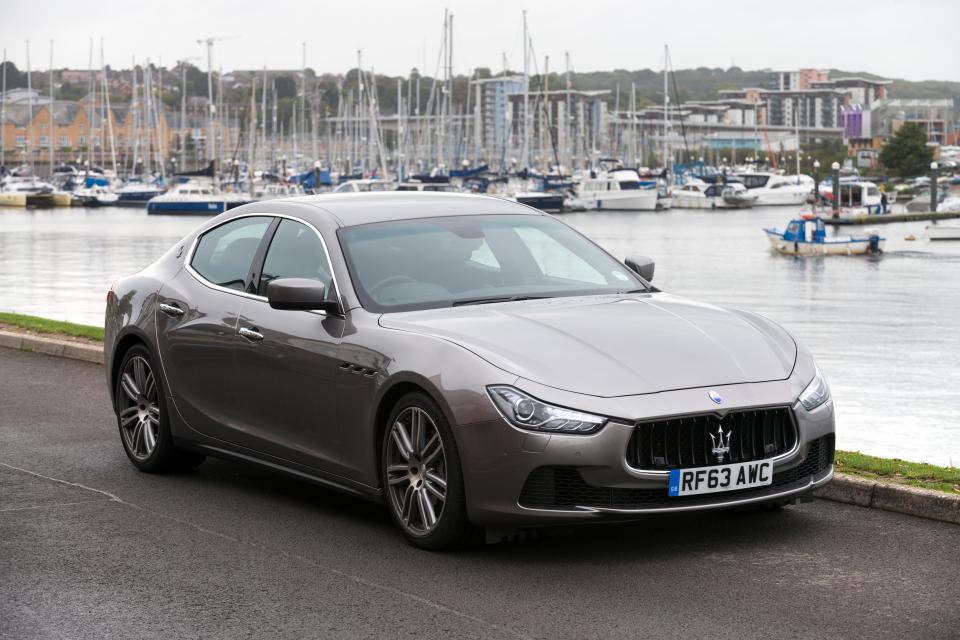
[157,216,276,439]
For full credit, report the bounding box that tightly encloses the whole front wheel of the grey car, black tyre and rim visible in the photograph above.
[380,392,481,550]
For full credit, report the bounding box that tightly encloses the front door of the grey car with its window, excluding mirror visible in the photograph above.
[225,218,344,474]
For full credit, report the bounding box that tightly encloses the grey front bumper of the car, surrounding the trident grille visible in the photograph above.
[457,383,834,526]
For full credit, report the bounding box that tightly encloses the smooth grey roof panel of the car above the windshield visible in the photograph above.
[282,191,546,227]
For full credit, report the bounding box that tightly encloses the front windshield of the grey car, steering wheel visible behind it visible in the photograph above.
[338,215,646,313]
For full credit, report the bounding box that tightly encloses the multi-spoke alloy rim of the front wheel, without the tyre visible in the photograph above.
[384,406,447,536]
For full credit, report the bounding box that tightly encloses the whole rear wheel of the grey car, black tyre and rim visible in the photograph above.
[113,345,206,473]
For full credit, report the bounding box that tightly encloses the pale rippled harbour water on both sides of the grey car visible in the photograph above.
[0,207,960,465]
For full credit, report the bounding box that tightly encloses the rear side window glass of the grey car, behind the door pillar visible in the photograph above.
[190,216,271,291]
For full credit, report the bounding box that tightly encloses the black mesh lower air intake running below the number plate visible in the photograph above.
[519,434,834,509]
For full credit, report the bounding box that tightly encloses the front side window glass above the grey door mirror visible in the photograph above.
[257,219,333,297]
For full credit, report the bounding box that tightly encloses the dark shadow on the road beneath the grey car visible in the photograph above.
[159,452,831,565]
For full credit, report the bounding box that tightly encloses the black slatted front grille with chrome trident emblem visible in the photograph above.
[627,407,797,471]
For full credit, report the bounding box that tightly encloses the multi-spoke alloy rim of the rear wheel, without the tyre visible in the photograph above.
[117,356,160,460]
